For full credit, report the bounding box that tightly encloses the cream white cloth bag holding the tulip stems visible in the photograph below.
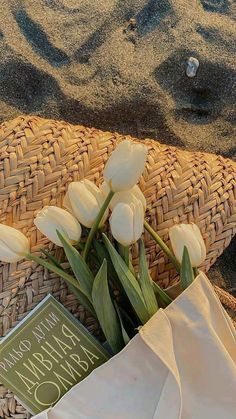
[35,273,236,419]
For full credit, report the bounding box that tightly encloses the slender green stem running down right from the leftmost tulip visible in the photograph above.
[27,253,96,317]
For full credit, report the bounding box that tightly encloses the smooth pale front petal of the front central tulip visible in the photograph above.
[110,203,133,246]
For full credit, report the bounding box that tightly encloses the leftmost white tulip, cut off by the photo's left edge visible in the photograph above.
[0,224,29,263]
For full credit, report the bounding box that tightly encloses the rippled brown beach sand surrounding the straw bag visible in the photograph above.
[0,0,236,292]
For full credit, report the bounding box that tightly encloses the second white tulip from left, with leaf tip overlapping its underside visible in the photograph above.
[34,206,81,247]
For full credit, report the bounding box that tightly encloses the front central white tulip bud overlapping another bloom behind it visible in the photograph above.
[110,199,144,246]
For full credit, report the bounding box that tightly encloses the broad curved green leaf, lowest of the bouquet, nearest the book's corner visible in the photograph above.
[92,259,124,354]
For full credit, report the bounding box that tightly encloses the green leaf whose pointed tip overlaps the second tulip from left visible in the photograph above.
[57,231,94,301]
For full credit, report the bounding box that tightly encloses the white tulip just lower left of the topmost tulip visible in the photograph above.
[63,179,109,228]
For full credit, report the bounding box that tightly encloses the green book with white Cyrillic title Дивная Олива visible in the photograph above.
[0,295,110,415]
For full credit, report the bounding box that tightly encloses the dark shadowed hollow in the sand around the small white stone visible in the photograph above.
[155,48,236,124]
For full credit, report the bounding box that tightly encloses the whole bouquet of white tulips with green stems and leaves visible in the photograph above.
[0,140,206,354]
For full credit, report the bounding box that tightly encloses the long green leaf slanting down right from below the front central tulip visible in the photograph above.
[103,234,150,324]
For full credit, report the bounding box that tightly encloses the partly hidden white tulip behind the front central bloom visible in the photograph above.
[101,182,147,212]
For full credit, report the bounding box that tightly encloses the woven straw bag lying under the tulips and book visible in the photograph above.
[0,116,236,419]
